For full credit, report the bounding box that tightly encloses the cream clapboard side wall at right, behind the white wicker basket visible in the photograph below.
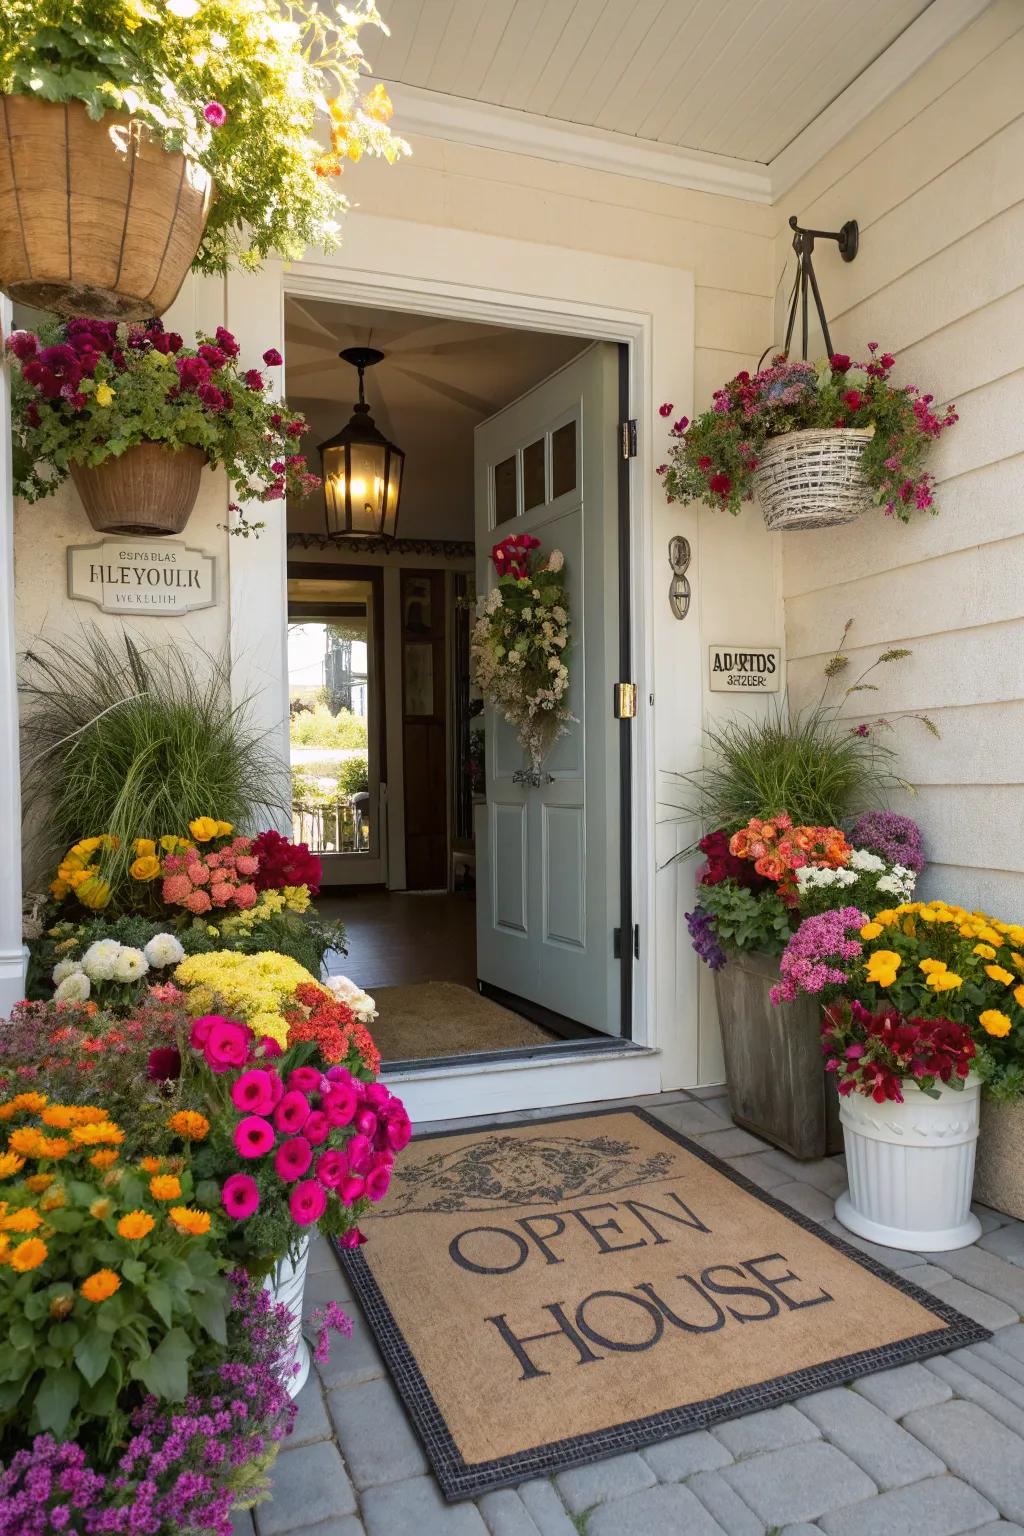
[775,0,1024,917]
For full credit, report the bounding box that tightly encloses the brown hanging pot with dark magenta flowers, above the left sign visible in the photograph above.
[8,318,319,535]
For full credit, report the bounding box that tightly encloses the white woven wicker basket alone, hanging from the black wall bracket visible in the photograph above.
[754,427,874,533]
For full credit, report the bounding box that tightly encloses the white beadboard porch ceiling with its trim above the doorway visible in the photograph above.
[362,0,989,201]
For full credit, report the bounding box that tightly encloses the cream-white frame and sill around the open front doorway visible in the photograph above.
[226,222,699,1118]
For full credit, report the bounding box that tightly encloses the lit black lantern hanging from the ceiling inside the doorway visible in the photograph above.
[319,347,405,539]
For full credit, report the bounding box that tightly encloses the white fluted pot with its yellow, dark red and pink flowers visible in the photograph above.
[772,900,1024,1250]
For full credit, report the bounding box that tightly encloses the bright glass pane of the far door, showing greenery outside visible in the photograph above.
[289,604,376,854]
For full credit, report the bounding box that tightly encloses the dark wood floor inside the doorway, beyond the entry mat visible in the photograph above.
[316,889,476,992]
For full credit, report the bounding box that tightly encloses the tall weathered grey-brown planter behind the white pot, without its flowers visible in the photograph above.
[715,952,843,1158]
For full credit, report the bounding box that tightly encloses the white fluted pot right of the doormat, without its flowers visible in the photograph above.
[835,1075,981,1253]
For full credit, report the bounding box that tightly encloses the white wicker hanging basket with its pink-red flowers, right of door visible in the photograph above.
[659,341,958,530]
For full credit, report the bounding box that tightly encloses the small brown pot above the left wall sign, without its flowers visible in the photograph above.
[71,442,206,535]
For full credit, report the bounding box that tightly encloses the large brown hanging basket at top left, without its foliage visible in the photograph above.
[0,95,212,319]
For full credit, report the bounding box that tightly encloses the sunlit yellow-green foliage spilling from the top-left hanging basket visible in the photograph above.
[0,0,408,272]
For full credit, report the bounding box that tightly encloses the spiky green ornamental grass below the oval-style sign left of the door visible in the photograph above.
[20,625,278,884]
